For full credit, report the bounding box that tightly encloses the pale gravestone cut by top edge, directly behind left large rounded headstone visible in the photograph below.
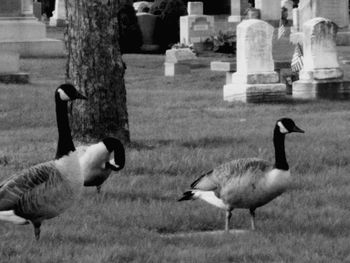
[255,0,281,26]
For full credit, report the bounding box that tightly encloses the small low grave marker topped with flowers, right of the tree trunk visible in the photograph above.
[164,48,197,76]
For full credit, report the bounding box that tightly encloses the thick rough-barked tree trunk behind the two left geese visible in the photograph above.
[65,0,130,142]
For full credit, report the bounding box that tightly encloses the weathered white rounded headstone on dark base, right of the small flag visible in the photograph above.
[292,17,350,99]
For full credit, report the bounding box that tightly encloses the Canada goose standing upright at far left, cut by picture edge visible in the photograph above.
[0,84,86,240]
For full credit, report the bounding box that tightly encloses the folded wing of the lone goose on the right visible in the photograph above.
[191,158,271,191]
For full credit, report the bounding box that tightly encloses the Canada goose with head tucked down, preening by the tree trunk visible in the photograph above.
[77,137,125,193]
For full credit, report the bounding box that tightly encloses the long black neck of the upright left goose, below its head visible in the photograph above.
[55,93,75,159]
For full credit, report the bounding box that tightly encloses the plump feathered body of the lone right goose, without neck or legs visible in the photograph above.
[192,158,292,209]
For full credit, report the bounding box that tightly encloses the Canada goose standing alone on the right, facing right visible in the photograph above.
[178,118,304,231]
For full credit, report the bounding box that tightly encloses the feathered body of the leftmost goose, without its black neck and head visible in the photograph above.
[0,152,84,225]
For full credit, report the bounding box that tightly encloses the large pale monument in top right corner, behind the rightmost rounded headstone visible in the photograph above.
[291,0,350,45]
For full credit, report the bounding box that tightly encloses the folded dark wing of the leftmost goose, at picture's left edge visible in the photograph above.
[0,162,57,211]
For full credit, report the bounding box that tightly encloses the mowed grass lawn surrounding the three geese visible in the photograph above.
[0,55,350,263]
